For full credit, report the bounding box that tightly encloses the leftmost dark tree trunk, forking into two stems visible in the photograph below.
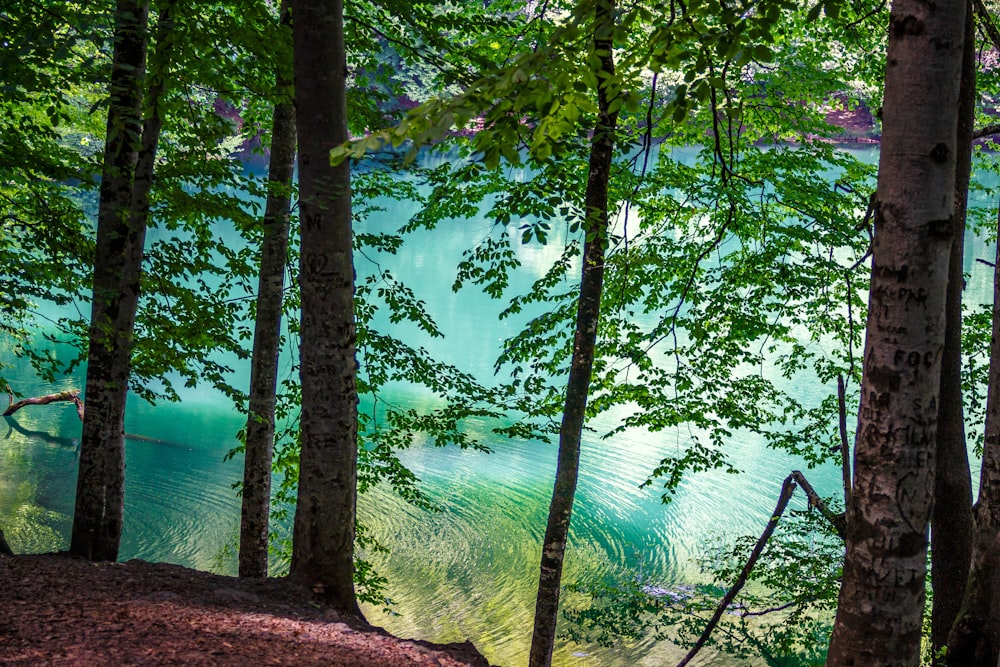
[70,0,173,560]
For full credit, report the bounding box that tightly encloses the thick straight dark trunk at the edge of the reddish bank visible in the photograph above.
[291,0,361,616]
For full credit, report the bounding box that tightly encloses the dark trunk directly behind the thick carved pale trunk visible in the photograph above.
[931,5,976,654]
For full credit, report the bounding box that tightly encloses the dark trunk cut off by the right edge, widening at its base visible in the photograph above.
[947,206,1000,667]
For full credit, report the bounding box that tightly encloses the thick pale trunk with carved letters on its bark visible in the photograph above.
[827,0,967,667]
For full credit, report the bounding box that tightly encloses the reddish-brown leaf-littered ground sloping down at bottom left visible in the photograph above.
[0,554,488,667]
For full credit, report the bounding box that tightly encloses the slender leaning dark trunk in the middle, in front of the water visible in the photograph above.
[528,0,618,667]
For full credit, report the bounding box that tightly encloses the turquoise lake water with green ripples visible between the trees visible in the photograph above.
[0,147,992,665]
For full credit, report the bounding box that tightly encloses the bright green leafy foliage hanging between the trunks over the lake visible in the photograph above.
[9,0,998,664]
